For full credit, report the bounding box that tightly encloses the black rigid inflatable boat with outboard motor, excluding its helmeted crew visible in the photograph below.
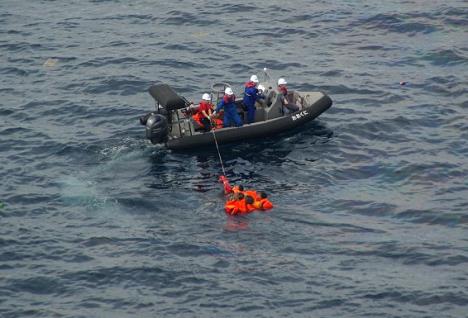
[140,83,332,149]
